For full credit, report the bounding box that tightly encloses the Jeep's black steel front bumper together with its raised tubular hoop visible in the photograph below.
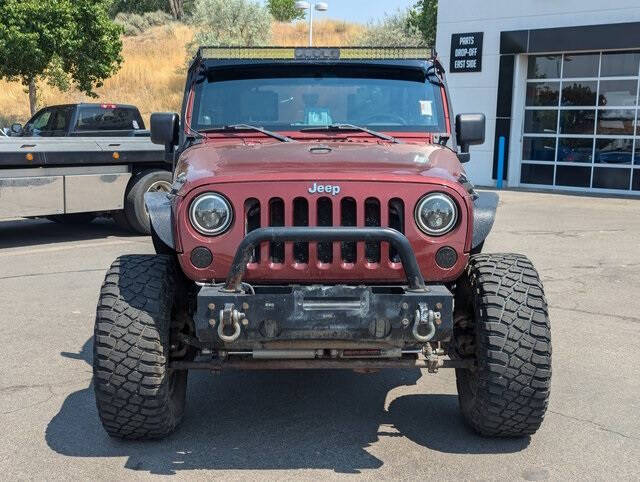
[194,227,453,347]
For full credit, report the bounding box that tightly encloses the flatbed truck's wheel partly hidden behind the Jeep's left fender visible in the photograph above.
[124,170,172,234]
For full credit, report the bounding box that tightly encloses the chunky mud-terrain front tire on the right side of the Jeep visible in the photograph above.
[454,254,551,437]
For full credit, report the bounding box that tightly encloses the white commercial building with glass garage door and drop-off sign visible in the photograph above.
[436,0,640,196]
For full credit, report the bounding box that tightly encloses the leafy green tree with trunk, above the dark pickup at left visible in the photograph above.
[0,0,122,114]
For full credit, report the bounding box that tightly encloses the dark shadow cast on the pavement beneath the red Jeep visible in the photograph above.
[46,340,529,474]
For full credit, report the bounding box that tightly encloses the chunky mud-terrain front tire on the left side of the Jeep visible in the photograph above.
[93,255,187,439]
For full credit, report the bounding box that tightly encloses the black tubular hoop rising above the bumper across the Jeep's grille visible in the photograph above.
[224,227,426,293]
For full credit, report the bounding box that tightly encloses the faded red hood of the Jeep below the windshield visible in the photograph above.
[176,142,464,190]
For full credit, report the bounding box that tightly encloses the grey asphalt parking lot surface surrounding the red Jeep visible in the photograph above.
[0,192,640,480]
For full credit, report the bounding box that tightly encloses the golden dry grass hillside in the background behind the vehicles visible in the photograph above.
[0,20,364,127]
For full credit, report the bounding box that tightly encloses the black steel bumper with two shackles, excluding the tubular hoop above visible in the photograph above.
[195,285,453,349]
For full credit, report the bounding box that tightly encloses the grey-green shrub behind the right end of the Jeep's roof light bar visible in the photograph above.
[353,10,425,47]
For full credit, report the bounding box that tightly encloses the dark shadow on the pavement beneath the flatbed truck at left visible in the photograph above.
[0,218,138,249]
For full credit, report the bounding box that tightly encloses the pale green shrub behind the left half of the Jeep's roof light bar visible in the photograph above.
[192,0,273,47]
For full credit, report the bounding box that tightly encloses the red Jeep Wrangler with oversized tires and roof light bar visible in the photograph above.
[93,48,551,439]
